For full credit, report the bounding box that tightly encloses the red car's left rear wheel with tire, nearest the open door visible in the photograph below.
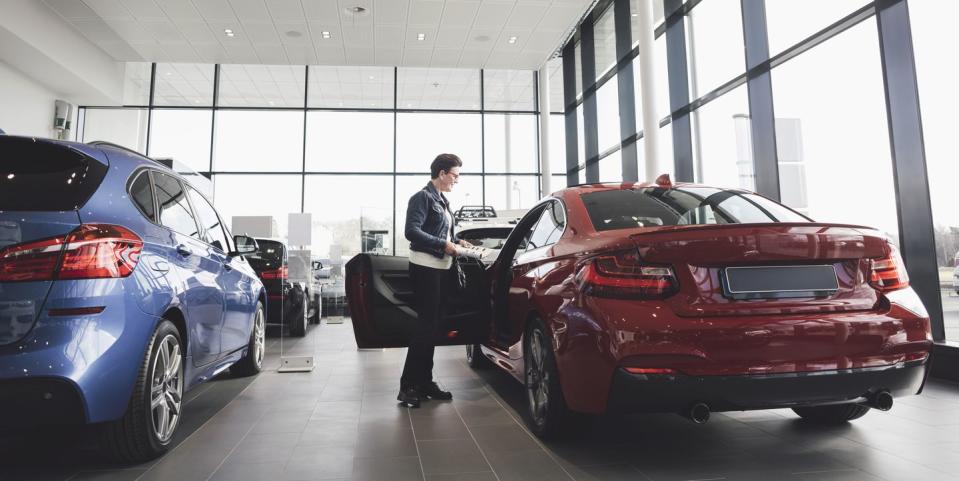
[523,319,587,439]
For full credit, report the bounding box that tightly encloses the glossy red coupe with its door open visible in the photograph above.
[347,178,932,436]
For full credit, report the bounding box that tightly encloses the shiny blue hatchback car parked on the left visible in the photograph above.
[0,135,266,462]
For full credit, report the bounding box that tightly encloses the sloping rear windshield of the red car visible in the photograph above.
[582,187,810,231]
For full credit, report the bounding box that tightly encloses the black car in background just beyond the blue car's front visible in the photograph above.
[246,239,309,337]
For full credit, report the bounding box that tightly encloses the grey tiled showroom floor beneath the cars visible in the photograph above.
[0,323,959,481]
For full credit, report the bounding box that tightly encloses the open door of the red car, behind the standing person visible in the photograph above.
[346,254,490,348]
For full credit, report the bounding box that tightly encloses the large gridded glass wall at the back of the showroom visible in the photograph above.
[78,62,540,258]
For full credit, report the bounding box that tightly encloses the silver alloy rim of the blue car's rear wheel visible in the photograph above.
[150,334,183,443]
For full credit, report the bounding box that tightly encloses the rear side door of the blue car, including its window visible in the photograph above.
[153,172,225,366]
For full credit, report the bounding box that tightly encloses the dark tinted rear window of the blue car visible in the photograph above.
[0,135,107,211]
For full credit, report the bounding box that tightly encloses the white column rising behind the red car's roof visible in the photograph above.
[633,0,671,182]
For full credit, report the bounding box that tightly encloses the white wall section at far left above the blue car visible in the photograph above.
[0,62,63,137]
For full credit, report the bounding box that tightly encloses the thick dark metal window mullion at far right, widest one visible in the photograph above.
[876,0,944,342]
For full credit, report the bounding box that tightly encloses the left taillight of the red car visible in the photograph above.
[580,251,678,299]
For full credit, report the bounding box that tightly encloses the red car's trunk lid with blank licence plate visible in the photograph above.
[630,223,888,317]
